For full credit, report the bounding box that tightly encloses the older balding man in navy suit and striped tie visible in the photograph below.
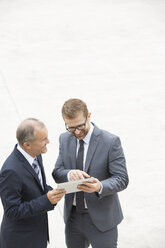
[0,118,65,248]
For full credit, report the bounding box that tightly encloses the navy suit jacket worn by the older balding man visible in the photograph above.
[0,147,54,248]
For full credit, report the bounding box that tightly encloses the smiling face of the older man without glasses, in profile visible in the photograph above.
[28,127,49,157]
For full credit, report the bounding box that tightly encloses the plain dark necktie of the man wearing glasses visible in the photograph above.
[76,140,85,212]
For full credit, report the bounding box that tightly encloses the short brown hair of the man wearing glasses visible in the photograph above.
[62,98,88,119]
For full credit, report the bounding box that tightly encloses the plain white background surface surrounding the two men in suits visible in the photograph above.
[0,0,165,248]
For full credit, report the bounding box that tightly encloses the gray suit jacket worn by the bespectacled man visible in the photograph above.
[52,125,128,231]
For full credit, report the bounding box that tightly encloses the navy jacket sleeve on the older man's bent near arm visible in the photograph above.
[0,170,54,219]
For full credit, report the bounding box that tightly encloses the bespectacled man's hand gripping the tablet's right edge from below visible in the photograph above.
[77,178,101,193]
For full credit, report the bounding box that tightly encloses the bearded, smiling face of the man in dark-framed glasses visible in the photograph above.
[64,112,91,140]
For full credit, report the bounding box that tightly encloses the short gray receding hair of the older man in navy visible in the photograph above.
[16,118,45,146]
